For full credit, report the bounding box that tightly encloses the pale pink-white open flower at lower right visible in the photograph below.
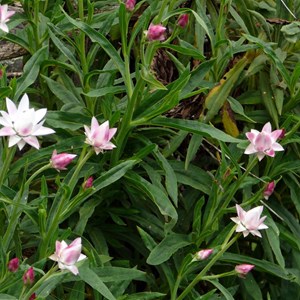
[231,204,268,237]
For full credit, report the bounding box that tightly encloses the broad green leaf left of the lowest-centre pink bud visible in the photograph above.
[147,233,192,265]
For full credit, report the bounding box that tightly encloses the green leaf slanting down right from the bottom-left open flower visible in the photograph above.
[78,267,116,300]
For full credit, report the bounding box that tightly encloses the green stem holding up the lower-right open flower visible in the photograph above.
[177,226,241,300]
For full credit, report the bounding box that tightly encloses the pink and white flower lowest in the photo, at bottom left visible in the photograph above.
[49,238,86,275]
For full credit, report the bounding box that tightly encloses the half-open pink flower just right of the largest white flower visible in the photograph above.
[84,117,117,155]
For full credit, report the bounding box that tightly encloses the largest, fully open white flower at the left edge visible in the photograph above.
[0,94,55,150]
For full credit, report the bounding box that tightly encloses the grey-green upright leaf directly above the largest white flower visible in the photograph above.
[15,46,48,99]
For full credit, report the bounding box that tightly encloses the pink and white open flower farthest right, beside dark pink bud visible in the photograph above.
[245,122,284,160]
